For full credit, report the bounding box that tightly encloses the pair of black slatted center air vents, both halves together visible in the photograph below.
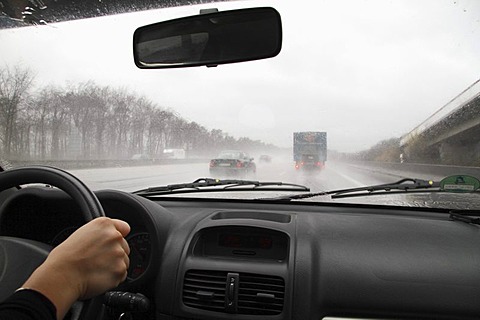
[183,270,285,315]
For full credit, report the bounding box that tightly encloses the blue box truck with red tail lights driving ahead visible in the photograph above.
[293,131,327,170]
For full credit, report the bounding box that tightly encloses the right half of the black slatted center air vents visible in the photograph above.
[237,273,285,315]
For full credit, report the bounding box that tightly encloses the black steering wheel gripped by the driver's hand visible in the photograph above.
[0,166,105,313]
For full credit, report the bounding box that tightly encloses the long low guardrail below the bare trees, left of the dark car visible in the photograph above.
[8,159,210,170]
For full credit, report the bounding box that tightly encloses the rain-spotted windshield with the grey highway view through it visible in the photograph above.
[0,0,480,209]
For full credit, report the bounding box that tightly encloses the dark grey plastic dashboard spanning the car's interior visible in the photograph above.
[0,188,480,320]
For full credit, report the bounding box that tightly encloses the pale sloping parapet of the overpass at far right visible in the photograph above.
[400,79,480,146]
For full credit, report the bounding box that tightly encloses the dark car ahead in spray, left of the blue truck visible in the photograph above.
[209,150,257,177]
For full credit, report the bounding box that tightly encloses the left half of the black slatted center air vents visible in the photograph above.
[183,270,227,312]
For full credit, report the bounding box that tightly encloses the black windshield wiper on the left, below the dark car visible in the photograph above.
[133,178,310,196]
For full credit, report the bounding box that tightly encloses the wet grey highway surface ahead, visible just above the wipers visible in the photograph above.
[71,160,392,192]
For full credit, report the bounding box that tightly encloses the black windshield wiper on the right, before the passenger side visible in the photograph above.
[270,178,442,201]
